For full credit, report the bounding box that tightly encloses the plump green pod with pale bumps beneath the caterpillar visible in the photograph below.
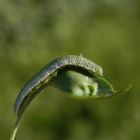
[51,71,116,99]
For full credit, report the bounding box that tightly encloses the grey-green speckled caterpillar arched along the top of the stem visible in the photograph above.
[15,55,103,115]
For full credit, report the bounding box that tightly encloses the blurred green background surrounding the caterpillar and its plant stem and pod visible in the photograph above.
[0,0,140,140]
